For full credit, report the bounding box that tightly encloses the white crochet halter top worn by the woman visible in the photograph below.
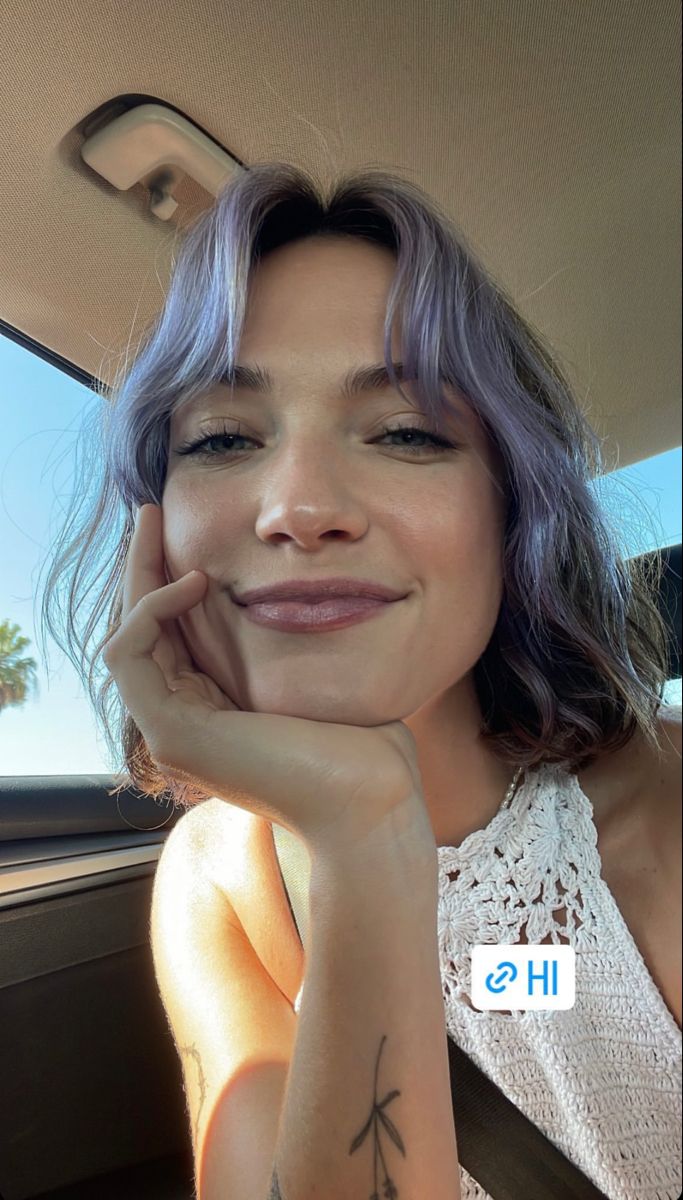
[289,764,683,1200]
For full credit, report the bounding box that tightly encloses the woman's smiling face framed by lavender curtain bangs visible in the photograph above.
[162,239,504,725]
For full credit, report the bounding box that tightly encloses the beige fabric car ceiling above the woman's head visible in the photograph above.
[0,0,681,469]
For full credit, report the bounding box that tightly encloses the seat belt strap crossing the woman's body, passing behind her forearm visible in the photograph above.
[272,823,609,1200]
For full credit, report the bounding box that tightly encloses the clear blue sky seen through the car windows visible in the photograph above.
[0,334,682,775]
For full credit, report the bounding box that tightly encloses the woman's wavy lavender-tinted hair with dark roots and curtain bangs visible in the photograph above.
[41,162,669,806]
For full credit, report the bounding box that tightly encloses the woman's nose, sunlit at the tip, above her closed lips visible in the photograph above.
[256,439,369,550]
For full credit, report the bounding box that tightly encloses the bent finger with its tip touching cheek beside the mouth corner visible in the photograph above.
[102,571,206,752]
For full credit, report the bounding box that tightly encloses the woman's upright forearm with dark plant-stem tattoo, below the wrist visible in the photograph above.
[266,820,460,1200]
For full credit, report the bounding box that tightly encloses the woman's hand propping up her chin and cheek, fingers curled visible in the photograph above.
[103,504,436,857]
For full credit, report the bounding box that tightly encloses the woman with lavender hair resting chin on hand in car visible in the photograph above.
[39,163,681,1200]
